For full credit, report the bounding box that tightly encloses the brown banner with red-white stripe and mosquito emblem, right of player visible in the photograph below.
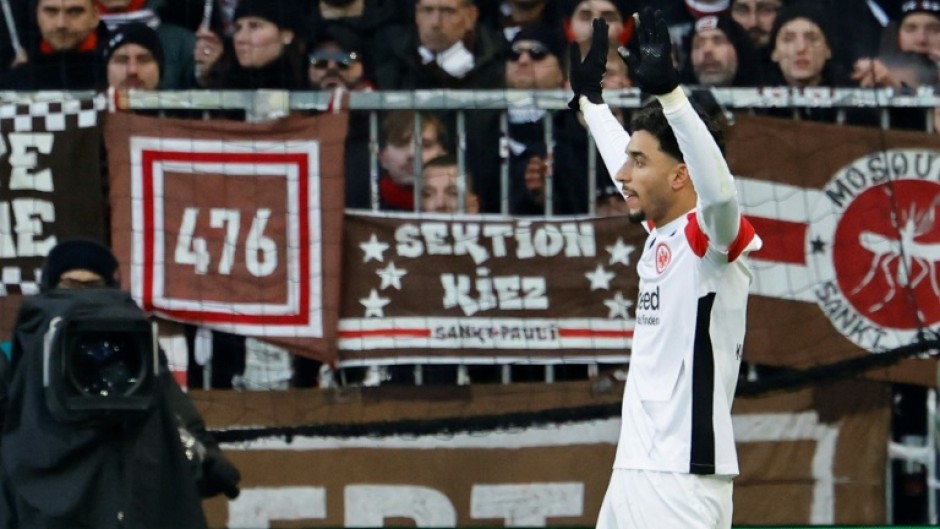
[728,116,940,372]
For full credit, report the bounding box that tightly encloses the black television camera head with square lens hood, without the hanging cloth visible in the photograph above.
[14,288,159,422]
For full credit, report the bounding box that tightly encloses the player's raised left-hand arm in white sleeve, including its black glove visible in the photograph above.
[568,18,630,192]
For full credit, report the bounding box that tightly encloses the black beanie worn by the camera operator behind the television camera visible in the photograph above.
[39,239,118,291]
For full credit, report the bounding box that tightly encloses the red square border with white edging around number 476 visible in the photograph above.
[131,138,322,336]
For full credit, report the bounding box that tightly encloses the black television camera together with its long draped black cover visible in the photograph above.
[0,288,214,529]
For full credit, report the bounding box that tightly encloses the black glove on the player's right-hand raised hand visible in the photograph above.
[624,6,679,95]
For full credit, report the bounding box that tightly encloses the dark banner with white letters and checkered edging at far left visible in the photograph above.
[0,97,107,337]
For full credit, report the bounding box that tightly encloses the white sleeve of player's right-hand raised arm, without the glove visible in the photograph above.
[659,87,741,251]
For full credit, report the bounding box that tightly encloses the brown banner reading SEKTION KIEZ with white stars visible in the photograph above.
[339,210,645,365]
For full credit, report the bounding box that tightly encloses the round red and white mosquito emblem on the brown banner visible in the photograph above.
[806,149,940,350]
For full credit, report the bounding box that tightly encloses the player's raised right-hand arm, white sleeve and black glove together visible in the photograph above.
[626,7,741,250]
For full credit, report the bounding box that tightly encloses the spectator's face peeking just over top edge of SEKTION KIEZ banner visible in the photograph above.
[421,154,480,213]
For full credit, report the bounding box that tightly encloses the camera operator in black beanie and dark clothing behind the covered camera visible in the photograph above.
[0,239,240,529]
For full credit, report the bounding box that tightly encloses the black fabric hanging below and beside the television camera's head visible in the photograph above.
[0,290,207,529]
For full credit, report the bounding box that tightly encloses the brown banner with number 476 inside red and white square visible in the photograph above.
[105,114,346,362]
